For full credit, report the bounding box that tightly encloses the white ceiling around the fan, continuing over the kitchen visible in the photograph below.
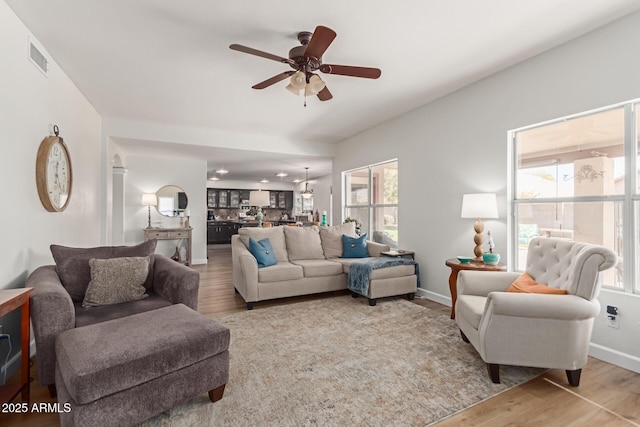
[6,0,640,180]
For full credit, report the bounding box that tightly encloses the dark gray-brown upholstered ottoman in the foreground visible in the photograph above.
[56,304,230,427]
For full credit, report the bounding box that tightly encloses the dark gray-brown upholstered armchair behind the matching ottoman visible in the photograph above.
[26,240,200,396]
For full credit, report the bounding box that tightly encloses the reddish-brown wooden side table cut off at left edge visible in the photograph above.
[0,288,33,405]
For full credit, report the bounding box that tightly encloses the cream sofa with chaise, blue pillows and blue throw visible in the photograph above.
[231,222,417,310]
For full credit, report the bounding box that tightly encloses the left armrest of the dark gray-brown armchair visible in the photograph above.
[25,265,76,386]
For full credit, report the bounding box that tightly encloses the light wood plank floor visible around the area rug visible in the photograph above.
[6,245,640,427]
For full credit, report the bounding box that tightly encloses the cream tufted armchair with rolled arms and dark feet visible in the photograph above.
[455,237,617,386]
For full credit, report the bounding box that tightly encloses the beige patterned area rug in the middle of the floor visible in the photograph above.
[139,295,543,426]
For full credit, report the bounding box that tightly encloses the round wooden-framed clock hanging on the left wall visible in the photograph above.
[36,126,73,212]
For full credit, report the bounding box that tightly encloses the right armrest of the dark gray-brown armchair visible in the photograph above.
[152,255,200,310]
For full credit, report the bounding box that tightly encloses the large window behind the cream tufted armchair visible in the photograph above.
[510,101,640,293]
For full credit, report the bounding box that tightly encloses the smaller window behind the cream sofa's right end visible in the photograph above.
[342,160,398,249]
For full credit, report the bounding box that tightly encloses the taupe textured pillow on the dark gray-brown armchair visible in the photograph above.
[82,256,150,307]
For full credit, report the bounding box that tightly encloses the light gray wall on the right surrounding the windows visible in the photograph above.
[333,10,640,372]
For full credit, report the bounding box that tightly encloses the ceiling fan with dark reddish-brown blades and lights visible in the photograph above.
[229,25,382,105]
